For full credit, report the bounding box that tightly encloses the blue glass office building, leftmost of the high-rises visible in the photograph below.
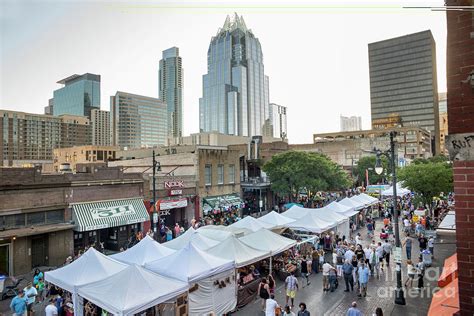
[53,73,100,117]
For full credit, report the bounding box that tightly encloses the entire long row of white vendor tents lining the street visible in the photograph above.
[45,194,378,315]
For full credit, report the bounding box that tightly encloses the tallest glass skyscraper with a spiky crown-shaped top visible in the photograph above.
[199,14,270,136]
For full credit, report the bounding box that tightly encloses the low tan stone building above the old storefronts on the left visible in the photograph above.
[53,145,119,172]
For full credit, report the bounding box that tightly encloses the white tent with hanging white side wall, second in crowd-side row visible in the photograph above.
[145,243,237,315]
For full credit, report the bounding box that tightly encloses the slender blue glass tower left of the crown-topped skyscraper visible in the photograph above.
[159,47,183,137]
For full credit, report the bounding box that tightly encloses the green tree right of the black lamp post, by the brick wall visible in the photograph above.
[398,160,453,208]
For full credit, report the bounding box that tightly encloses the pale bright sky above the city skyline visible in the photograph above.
[0,0,446,143]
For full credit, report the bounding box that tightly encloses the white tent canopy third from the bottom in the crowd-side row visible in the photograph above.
[206,236,270,268]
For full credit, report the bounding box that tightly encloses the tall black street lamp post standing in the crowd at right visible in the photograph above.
[374,131,406,305]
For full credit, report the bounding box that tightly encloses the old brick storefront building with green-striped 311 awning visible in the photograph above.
[0,166,149,275]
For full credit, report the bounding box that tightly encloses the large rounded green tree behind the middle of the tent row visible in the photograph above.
[263,151,350,200]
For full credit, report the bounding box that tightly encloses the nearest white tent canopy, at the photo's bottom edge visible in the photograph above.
[78,265,189,315]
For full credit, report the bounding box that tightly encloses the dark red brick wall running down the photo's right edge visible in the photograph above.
[446,0,474,315]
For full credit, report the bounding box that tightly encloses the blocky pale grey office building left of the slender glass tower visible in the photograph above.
[110,91,168,148]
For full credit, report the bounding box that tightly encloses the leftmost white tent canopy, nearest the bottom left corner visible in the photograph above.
[45,248,127,293]
